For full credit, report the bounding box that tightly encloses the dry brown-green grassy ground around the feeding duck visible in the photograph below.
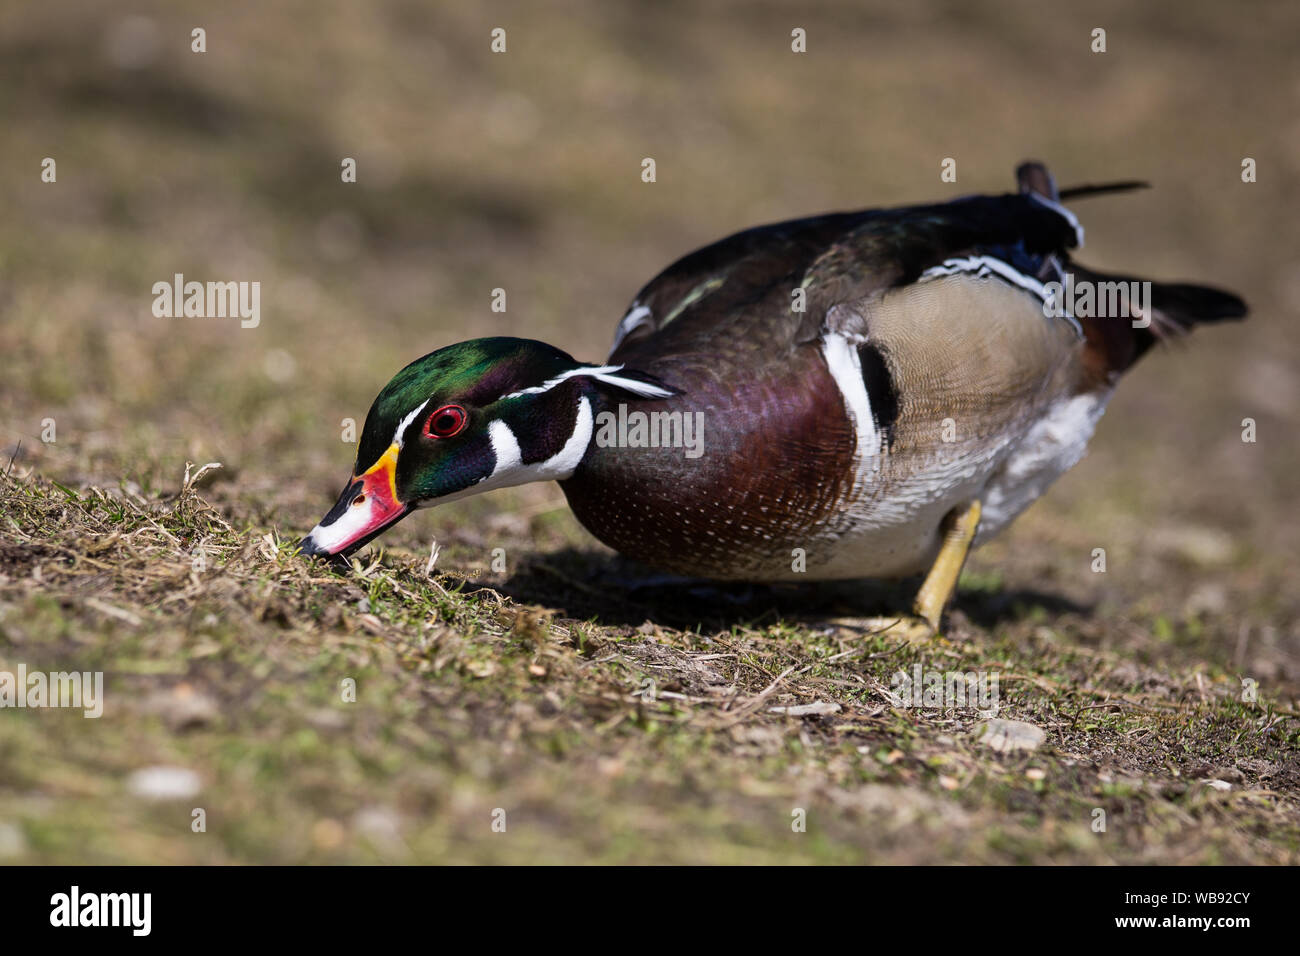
[0,3,1300,864]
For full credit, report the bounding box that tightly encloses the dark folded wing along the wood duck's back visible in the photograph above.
[610,184,1082,367]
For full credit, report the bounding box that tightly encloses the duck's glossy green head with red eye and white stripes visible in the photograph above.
[299,338,673,557]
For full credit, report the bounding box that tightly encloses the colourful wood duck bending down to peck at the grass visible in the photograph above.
[300,163,1245,628]
